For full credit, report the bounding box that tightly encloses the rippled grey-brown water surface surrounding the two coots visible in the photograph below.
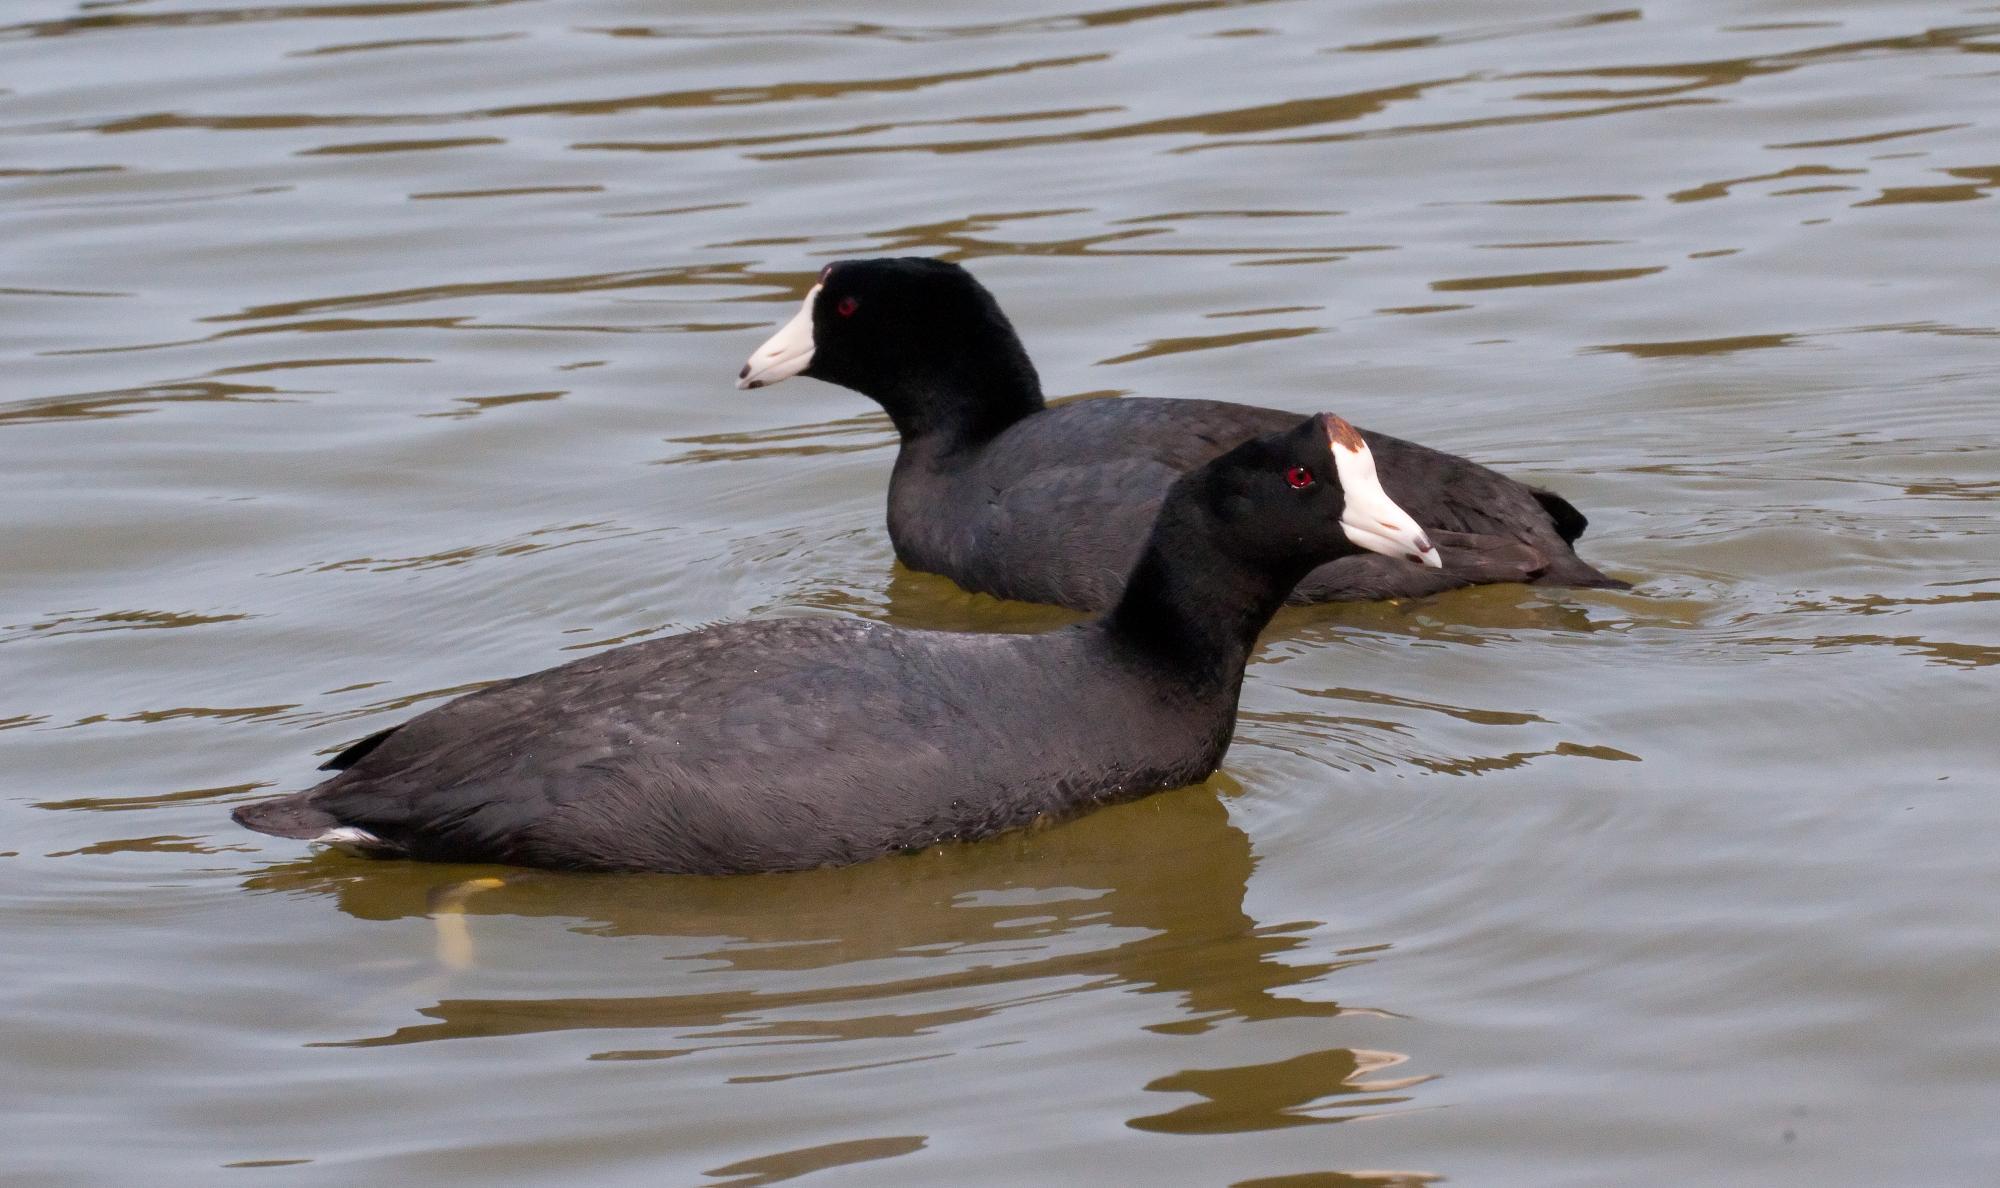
[0,0,2000,1188]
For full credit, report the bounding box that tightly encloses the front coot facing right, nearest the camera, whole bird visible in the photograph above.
[234,416,1432,874]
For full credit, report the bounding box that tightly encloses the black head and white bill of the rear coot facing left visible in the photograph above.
[736,256,1042,438]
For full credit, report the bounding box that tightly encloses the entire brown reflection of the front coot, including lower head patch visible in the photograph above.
[246,776,1428,1134]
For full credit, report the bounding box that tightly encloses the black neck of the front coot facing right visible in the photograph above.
[1098,498,1312,702]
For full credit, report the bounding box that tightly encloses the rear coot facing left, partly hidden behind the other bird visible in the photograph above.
[736,256,1626,610]
